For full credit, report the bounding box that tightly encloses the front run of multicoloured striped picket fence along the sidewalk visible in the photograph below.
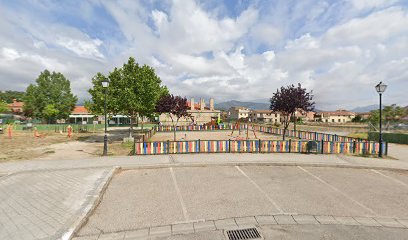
[134,140,387,155]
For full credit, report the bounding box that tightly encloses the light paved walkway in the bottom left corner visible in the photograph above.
[0,169,112,240]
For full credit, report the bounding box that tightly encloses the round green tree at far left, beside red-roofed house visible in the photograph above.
[23,70,78,122]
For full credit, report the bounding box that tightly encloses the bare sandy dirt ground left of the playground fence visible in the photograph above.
[0,128,148,162]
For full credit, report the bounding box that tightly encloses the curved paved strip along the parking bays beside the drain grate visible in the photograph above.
[74,214,408,239]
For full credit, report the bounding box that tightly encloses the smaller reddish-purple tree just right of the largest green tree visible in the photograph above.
[156,95,190,141]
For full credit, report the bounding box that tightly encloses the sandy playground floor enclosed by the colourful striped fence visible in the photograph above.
[150,131,282,141]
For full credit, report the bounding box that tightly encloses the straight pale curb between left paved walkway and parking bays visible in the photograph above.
[58,166,119,240]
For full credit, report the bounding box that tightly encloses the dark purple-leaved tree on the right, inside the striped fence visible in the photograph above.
[270,83,314,140]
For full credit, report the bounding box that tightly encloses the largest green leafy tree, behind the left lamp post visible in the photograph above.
[85,57,168,135]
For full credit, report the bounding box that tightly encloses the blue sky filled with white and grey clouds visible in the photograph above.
[0,0,408,109]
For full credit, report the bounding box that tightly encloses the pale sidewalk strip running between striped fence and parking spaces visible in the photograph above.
[0,149,408,176]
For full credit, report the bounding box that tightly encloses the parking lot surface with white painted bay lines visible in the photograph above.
[78,166,408,236]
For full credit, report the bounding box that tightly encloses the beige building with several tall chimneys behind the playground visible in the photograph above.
[159,98,221,126]
